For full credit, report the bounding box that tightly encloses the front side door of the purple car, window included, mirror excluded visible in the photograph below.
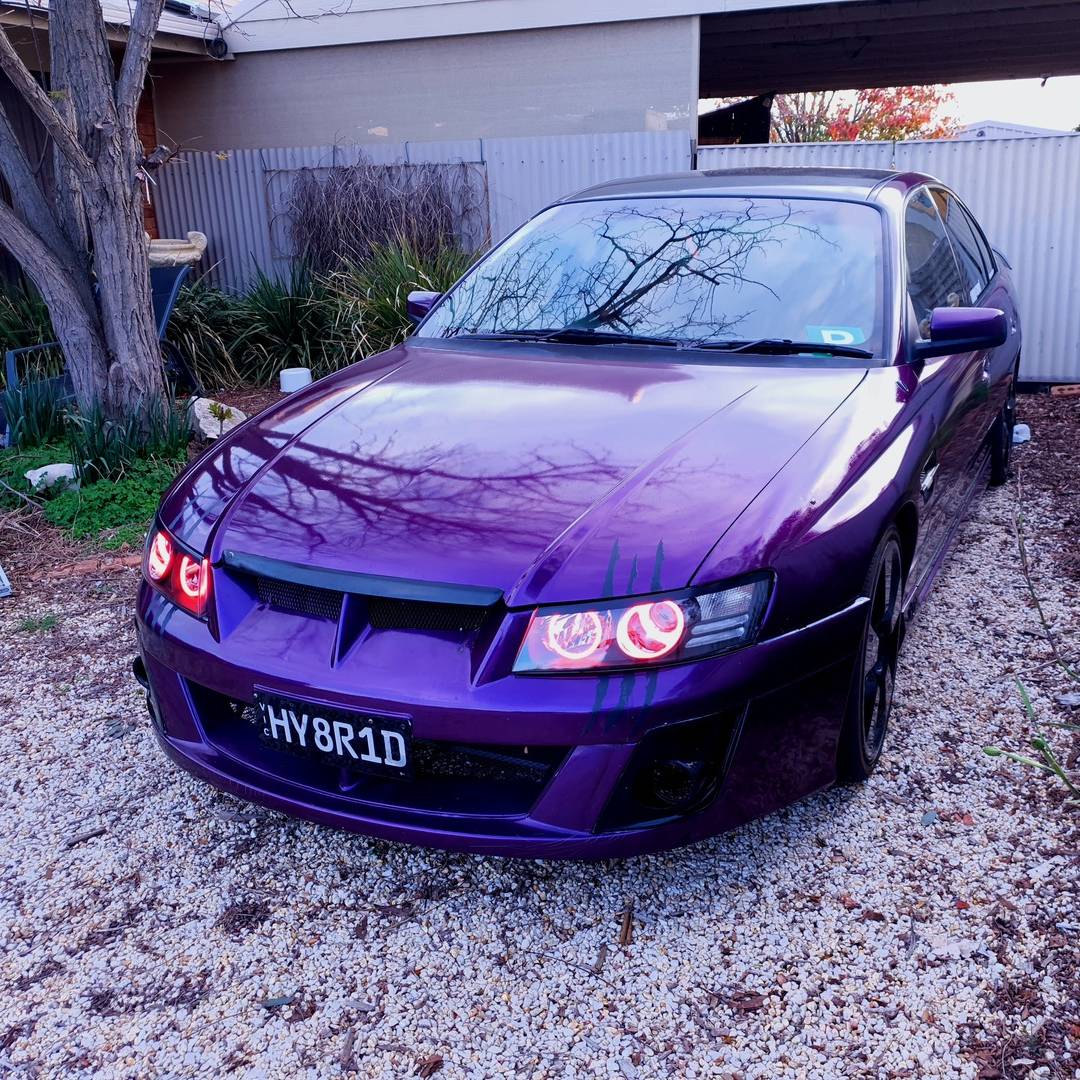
[904,187,988,581]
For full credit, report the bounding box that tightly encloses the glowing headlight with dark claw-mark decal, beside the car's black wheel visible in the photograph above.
[514,573,772,673]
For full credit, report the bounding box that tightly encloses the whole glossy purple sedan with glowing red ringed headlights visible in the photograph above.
[135,170,1021,858]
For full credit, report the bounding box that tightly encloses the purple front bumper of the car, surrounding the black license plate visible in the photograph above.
[136,585,866,859]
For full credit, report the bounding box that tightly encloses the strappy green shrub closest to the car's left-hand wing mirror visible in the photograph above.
[325,241,475,363]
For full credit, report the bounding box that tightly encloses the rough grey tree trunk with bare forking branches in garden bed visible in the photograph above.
[0,0,164,418]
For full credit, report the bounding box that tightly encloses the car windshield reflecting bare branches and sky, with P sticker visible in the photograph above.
[418,197,882,356]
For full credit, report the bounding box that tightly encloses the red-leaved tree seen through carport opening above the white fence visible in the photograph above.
[772,86,956,143]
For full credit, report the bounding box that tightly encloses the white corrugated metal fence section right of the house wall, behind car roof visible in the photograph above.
[698,135,1080,382]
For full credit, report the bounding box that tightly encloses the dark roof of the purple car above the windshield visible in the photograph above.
[559,165,939,202]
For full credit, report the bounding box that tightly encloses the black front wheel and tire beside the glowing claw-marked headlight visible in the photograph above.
[837,526,904,784]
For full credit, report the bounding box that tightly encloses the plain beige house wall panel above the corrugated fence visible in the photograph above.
[154,16,699,150]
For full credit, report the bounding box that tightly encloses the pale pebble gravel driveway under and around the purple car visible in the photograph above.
[0,401,1080,1078]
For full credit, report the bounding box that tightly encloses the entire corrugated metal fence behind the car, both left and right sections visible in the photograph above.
[156,132,1080,382]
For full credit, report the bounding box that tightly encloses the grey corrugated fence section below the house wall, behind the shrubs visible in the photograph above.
[154,132,692,292]
